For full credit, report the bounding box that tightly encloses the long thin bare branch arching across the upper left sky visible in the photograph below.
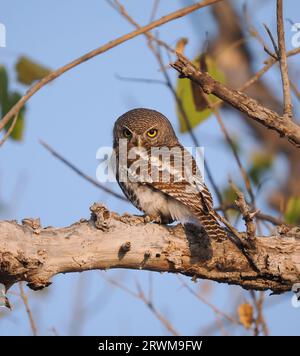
[0,0,222,136]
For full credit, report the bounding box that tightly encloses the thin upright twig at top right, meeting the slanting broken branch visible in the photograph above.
[277,0,293,119]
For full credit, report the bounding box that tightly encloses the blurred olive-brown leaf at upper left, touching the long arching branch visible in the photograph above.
[16,57,51,85]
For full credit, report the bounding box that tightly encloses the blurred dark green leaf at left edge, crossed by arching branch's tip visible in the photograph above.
[2,92,25,141]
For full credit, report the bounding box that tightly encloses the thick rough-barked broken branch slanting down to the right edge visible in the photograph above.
[171,53,300,148]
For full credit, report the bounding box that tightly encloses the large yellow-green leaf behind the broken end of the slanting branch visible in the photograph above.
[176,56,225,132]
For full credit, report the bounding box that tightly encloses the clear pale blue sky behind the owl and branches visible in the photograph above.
[0,0,300,335]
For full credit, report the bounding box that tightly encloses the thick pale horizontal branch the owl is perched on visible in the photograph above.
[0,204,300,293]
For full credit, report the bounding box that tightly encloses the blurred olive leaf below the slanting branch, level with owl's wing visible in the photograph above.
[248,152,274,185]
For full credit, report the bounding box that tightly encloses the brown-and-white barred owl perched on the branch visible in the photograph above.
[113,108,227,239]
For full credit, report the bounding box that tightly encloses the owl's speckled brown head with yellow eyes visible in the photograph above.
[113,108,178,148]
